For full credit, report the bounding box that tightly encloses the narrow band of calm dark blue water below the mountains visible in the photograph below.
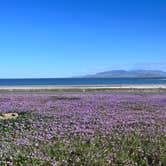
[0,78,166,86]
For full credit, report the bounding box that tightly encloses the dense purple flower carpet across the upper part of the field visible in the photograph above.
[0,94,166,139]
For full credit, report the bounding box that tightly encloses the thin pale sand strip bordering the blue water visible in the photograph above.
[0,84,166,91]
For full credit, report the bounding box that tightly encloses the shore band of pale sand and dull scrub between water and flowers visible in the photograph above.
[0,84,166,92]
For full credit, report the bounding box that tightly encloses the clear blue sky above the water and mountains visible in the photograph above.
[0,0,166,78]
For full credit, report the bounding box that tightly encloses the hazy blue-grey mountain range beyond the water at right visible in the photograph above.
[84,70,166,78]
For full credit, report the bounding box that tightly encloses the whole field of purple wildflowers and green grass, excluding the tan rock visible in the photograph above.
[0,94,166,166]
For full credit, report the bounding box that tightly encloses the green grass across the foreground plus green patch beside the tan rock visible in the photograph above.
[0,112,166,166]
